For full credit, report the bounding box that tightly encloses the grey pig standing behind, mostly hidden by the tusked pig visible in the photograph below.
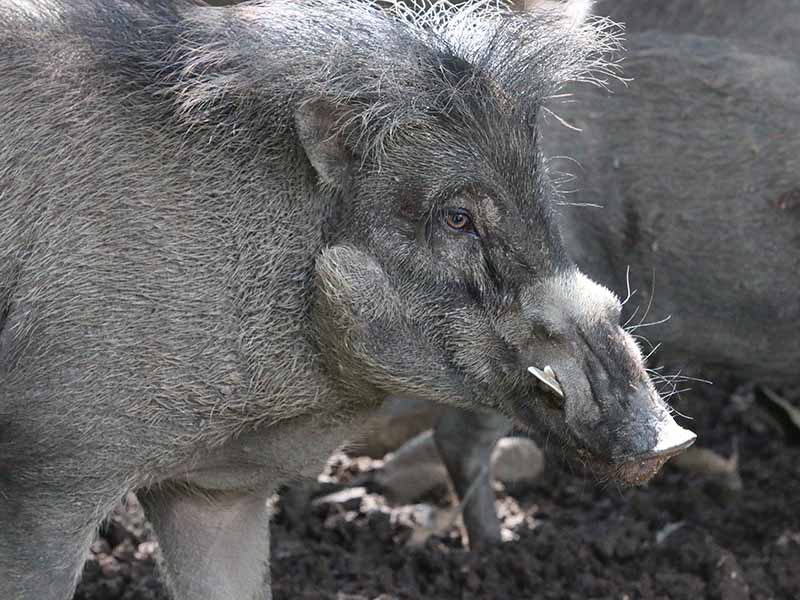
[418,0,800,545]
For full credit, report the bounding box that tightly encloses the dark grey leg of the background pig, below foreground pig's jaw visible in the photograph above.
[434,408,510,548]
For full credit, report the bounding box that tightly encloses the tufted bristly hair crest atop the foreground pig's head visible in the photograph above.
[166,0,620,159]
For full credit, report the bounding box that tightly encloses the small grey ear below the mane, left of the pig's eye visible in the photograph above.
[294,99,353,189]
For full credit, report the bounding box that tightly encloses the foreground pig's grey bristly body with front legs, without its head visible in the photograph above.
[0,2,354,600]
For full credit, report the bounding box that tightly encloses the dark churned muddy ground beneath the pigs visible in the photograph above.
[75,382,800,600]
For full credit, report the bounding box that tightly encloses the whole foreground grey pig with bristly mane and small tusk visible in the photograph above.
[0,0,694,600]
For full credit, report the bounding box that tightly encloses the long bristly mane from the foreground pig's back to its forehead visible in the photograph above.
[0,0,620,164]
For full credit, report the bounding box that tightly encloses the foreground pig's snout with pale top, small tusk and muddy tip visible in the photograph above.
[526,273,696,485]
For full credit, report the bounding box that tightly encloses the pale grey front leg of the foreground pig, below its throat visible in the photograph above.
[139,486,272,600]
